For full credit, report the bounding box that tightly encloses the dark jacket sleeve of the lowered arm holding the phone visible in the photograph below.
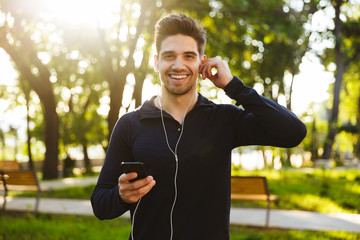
[91,116,132,220]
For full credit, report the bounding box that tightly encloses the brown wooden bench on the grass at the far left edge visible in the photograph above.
[0,161,41,213]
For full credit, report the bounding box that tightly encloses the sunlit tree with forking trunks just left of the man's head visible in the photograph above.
[99,0,158,144]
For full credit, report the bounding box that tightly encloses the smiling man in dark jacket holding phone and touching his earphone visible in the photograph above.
[91,14,306,240]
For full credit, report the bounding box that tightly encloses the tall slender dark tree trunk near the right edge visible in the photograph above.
[322,0,345,160]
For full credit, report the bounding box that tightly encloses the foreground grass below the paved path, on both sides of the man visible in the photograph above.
[0,213,360,240]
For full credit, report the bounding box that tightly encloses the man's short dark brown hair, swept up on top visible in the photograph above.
[155,13,206,56]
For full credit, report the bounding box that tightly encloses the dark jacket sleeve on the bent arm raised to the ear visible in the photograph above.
[224,76,307,148]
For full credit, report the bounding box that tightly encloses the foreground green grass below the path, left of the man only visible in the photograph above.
[0,213,131,240]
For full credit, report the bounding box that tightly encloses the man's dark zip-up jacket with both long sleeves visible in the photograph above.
[91,76,306,240]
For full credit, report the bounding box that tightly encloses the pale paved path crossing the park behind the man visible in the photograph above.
[0,177,360,233]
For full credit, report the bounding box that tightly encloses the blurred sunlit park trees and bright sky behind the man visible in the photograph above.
[0,0,360,179]
